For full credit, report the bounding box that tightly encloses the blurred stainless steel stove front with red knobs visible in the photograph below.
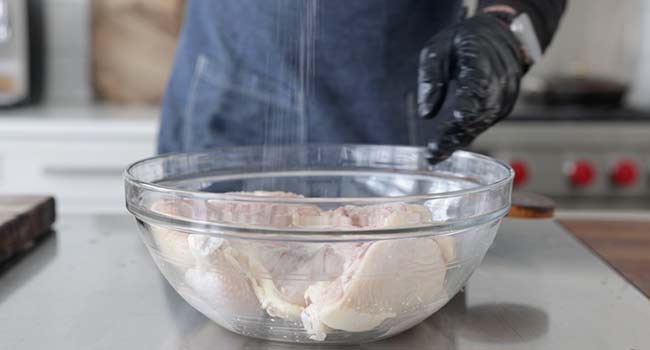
[473,109,650,209]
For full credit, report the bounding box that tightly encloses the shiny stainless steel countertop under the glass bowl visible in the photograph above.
[0,215,650,350]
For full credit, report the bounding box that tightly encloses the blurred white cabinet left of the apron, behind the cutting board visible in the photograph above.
[0,107,157,213]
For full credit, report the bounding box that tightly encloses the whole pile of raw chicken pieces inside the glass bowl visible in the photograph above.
[152,191,456,340]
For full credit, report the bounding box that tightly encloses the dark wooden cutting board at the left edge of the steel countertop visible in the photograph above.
[0,195,56,263]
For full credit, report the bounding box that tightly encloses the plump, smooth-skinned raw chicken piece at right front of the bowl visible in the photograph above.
[302,238,446,338]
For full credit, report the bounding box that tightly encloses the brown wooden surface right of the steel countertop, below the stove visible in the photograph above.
[560,219,650,297]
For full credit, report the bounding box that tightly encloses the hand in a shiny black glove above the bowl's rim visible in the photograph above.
[418,13,527,163]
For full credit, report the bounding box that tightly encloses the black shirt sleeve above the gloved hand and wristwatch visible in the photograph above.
[478,0,567,50]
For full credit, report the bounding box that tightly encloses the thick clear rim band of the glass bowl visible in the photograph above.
[123,144,514,240]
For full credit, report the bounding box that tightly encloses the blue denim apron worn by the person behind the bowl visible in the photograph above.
[158,0,461,153]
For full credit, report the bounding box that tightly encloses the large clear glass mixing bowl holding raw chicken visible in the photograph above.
[125,145,513,343]
